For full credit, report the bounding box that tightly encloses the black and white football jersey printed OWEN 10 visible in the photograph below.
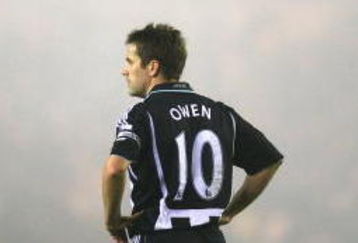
[111,82,282,232]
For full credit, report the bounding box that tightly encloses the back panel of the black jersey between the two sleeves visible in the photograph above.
[121,83,235,233]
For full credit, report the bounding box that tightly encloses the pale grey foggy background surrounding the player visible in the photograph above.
[0,0,358,243]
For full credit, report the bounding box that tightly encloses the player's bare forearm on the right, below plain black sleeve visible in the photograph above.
[219,160,282,224]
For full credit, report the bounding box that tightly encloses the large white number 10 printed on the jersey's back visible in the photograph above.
[174,130,224,200]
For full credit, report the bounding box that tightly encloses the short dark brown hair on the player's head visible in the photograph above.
[126,23,187,80]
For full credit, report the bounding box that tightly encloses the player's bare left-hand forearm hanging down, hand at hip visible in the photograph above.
[102,155,140,237]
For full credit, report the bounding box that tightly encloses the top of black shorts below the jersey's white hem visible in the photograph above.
[132,226,225,243]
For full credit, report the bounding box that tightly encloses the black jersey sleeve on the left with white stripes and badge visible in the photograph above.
[111,103,146,161]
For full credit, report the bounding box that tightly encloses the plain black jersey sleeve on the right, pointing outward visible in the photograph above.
[229,106,283,175]
